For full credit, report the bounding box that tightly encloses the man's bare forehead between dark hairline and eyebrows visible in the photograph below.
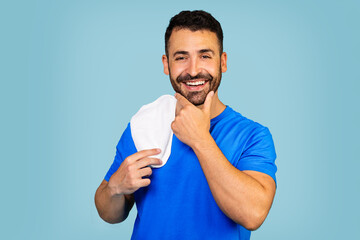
[169,29,219,54]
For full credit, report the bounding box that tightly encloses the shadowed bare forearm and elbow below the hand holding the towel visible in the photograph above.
[95,182,133,223]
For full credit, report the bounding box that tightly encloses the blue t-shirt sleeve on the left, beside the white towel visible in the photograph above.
[104,123,137,182]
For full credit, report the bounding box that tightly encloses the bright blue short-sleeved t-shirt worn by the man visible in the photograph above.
[105,106,277,240]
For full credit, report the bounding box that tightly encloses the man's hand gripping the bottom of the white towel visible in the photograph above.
[108,149,161,195]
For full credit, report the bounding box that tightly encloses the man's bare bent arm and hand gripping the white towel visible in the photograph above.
[95,149,161,223]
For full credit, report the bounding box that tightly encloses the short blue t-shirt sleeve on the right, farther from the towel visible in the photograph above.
[236,127,277,183]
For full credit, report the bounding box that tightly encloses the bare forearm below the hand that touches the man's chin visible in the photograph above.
[192,134,272,230]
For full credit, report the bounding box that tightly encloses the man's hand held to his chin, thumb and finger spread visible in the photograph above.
[171,91,214,148]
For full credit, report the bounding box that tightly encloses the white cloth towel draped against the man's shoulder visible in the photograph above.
[130,95,177,168]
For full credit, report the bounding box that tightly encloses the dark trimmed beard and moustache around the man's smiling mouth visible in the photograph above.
[169,66,222,106]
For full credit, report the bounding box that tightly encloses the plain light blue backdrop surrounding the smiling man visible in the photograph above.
[0,0,360,240]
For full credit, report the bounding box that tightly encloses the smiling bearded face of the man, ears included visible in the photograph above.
[163,29,227,106]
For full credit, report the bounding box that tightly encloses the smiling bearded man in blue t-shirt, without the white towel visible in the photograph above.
[95,11,276,239]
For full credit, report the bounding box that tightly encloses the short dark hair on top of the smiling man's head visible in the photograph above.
[165,10,224,56]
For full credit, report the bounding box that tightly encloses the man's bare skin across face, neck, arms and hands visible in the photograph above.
[95,29,276,230]
